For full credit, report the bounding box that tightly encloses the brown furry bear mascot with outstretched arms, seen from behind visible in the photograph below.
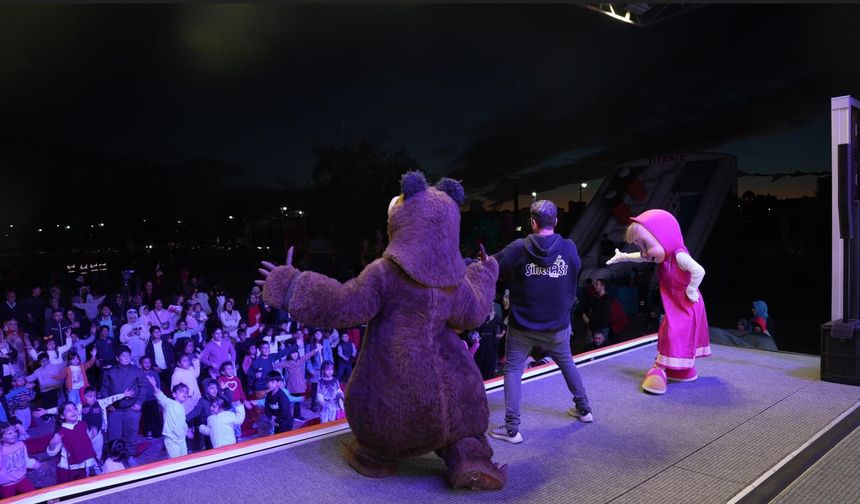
[259,172,506,490]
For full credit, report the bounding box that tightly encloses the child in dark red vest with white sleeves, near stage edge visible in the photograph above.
[47,401,96,483]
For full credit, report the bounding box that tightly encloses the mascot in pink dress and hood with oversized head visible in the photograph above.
[606,209,711,394]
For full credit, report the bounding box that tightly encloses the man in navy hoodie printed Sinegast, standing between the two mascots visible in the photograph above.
[490,200,594,443]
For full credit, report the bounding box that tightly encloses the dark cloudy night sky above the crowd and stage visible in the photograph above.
[0,4,860,226]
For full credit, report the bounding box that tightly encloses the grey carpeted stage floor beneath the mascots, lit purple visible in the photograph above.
[85,344,860,504]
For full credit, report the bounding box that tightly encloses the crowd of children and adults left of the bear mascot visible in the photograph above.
[0,275,363,497]
